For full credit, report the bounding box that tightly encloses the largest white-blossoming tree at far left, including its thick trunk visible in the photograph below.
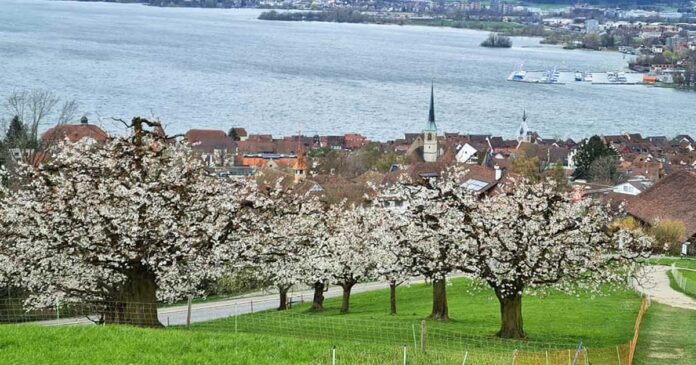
[0,118,256,326]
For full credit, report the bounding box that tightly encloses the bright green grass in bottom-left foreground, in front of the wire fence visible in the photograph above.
[0,325,331,365]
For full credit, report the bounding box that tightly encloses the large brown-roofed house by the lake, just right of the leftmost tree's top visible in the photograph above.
[184,129,236,167]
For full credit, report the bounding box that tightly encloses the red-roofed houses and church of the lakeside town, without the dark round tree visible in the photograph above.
[21,90,696,253]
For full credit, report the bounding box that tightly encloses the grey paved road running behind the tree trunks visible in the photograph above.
[40,275,463,326]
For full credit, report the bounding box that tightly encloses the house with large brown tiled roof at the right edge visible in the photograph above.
[626,170,696,252]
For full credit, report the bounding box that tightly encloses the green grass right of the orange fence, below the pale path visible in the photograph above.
[635,303,696,365]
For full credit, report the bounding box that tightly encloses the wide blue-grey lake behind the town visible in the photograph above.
[0,0,696,139]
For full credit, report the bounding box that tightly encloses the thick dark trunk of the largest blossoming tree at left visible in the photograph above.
[102,265,162,327]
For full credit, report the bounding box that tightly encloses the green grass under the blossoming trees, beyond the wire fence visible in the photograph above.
[195,279,640,349]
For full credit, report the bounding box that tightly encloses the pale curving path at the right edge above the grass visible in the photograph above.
[634,266,696,310]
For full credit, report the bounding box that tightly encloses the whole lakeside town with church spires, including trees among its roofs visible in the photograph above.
[4,89,696,254]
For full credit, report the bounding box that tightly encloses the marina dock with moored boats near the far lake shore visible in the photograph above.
[508,70,644,85]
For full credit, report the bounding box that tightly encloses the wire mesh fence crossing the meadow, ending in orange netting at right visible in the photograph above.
[0,297,648,365]
